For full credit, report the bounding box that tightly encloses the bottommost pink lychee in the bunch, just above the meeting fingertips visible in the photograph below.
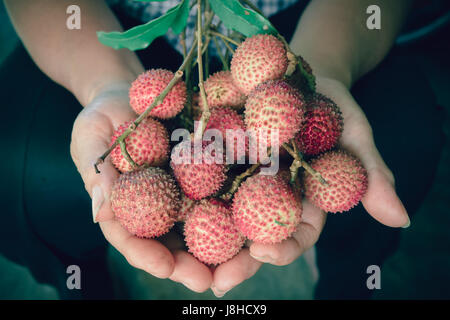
[184,199,245,265]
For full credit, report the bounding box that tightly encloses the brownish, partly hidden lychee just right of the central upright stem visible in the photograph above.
[200,71,247,109]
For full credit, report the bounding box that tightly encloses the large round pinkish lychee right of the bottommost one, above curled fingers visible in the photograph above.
[232,175,302,244]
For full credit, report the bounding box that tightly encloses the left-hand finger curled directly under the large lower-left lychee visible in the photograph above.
[100,220,175,278]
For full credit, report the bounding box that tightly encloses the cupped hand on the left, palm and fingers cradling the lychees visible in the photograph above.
[70,84,212,292]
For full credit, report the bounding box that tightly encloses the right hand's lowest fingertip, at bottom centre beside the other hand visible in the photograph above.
[211,248,261,298]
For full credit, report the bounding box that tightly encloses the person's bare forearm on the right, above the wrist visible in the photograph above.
[291,0,411,87]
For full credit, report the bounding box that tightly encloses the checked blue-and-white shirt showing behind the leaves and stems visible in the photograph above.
[109,0,297,55]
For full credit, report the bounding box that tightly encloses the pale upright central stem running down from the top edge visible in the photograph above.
[194,0,211,140]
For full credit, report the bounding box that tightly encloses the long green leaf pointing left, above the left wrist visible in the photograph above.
[97,0,189,51]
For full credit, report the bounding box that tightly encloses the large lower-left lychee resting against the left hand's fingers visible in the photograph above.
[111,168,180,238]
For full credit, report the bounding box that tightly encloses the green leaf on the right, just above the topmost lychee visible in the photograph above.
[209,0,278,37]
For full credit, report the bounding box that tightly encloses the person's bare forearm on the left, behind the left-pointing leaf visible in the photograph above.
[5,0,143,106]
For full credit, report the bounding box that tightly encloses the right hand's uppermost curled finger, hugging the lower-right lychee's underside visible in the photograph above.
[250,200,326,266]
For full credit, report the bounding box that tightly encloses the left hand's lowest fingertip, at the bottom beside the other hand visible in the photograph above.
[170,250,213,292]
